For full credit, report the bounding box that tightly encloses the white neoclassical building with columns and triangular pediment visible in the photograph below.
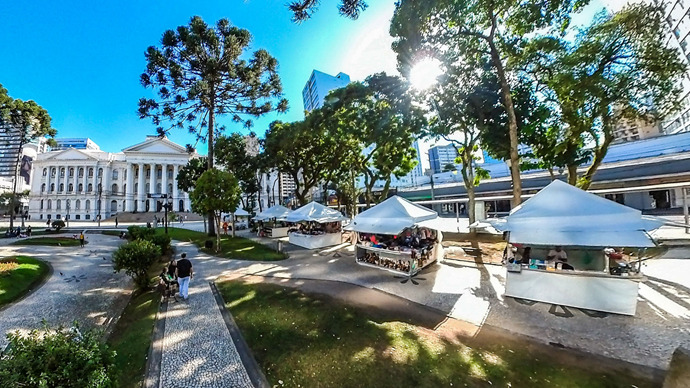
[29,136,199,221]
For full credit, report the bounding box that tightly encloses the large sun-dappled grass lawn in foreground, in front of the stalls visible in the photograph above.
[218,281,654,387]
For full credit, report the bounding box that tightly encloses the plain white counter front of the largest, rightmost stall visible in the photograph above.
[505,268,644,315]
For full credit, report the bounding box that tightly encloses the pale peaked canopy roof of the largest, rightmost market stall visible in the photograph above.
[487,180,663,248]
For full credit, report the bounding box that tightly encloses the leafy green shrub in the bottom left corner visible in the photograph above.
[0,326,116,388]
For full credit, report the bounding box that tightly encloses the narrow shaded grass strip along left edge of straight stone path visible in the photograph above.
[107,262,164,388]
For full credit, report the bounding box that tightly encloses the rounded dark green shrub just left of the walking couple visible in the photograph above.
[113,240,161,288]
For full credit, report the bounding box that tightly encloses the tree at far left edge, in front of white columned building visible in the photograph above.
[0,85,57,229]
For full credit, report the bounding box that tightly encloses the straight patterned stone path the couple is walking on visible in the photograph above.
[160,242,252,388]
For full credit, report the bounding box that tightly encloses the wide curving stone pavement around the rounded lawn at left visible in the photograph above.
[0,234,132,349]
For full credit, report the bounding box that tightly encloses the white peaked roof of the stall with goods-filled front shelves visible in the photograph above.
[349,195,438,234]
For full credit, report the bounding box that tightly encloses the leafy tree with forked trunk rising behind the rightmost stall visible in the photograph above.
[525,4,687,189]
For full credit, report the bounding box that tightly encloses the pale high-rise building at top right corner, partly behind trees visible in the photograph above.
[653,0,690,134]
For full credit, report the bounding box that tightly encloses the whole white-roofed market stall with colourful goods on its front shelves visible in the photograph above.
[348,196,443,275]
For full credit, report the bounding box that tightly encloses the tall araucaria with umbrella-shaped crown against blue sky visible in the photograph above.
[139,16,287,235]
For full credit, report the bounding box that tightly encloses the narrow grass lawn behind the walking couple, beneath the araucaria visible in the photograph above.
[157,228,286,261]
